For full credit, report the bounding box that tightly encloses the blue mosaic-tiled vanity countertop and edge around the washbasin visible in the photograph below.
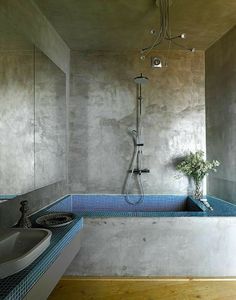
[0,212,83,300]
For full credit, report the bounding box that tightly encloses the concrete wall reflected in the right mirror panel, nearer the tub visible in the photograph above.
[35,50,66,189]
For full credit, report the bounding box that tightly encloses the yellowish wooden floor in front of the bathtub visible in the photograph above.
[48,276,236,300]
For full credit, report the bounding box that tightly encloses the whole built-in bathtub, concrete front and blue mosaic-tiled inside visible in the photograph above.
[48,195,236,277]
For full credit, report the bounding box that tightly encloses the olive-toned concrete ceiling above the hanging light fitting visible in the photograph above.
[34,0,236,51]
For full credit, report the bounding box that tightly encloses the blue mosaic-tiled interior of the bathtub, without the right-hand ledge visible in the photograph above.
[49,195,206,216]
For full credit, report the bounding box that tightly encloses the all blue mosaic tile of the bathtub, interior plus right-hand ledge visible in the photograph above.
[48,194,236,217]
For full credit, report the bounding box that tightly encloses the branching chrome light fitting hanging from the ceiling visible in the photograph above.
[140,0,195,59]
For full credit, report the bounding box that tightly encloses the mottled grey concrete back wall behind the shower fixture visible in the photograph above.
[69,51,205,194]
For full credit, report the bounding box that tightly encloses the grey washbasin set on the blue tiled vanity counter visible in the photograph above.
[0,228,52,279]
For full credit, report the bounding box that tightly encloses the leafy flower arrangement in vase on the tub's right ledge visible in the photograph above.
[176,151,220,199]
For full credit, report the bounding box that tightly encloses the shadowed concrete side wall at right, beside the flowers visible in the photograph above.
[206,27,236,203]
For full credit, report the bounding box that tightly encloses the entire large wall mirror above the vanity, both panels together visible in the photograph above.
[0,16,66,200]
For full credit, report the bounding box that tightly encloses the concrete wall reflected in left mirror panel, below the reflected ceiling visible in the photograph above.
[0,46,34,194]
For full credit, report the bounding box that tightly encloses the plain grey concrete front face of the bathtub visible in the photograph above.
[65,217,236,277]
